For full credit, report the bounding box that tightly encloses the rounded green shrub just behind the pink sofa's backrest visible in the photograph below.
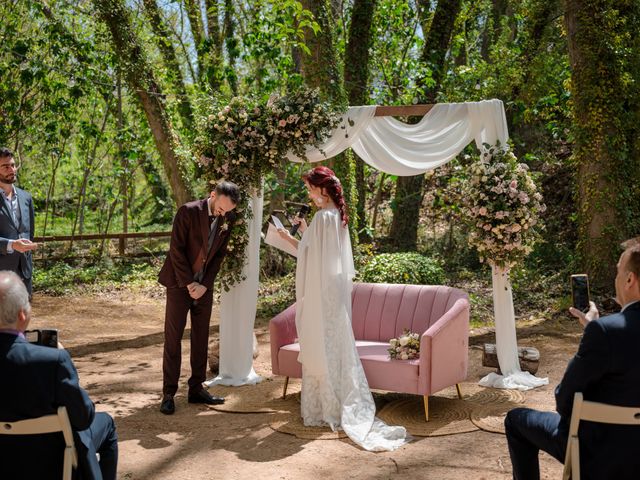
[358,253,445,285]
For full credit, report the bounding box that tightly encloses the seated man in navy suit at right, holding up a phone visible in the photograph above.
[505,237,640,480]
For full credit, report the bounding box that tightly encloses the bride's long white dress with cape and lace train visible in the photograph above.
[296,208,410,451]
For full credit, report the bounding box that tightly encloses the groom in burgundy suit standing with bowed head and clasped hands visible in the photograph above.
[158,181,240,415]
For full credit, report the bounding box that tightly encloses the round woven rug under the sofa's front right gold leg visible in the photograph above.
[377,395,478,437]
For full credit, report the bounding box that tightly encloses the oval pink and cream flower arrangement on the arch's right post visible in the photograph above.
[462,143,546,268]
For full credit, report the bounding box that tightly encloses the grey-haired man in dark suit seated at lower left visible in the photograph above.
[0,270,118,480]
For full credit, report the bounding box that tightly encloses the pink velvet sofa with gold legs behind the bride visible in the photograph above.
[269,283,469,421]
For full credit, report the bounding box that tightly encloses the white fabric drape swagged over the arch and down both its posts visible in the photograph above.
[220,100,546,389]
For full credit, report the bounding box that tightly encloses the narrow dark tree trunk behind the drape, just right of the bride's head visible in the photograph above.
[344,0,376,242]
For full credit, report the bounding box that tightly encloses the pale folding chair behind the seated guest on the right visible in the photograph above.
[562,392,640,480]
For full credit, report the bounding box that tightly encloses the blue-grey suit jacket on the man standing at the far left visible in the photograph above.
[0,187,35,280]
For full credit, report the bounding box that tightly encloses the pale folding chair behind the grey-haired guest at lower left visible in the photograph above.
[0,407,78,480]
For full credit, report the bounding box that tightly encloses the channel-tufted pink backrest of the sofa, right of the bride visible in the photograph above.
[352,283,468,342]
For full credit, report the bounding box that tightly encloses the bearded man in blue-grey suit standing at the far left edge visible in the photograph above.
[0,148,38,298]
